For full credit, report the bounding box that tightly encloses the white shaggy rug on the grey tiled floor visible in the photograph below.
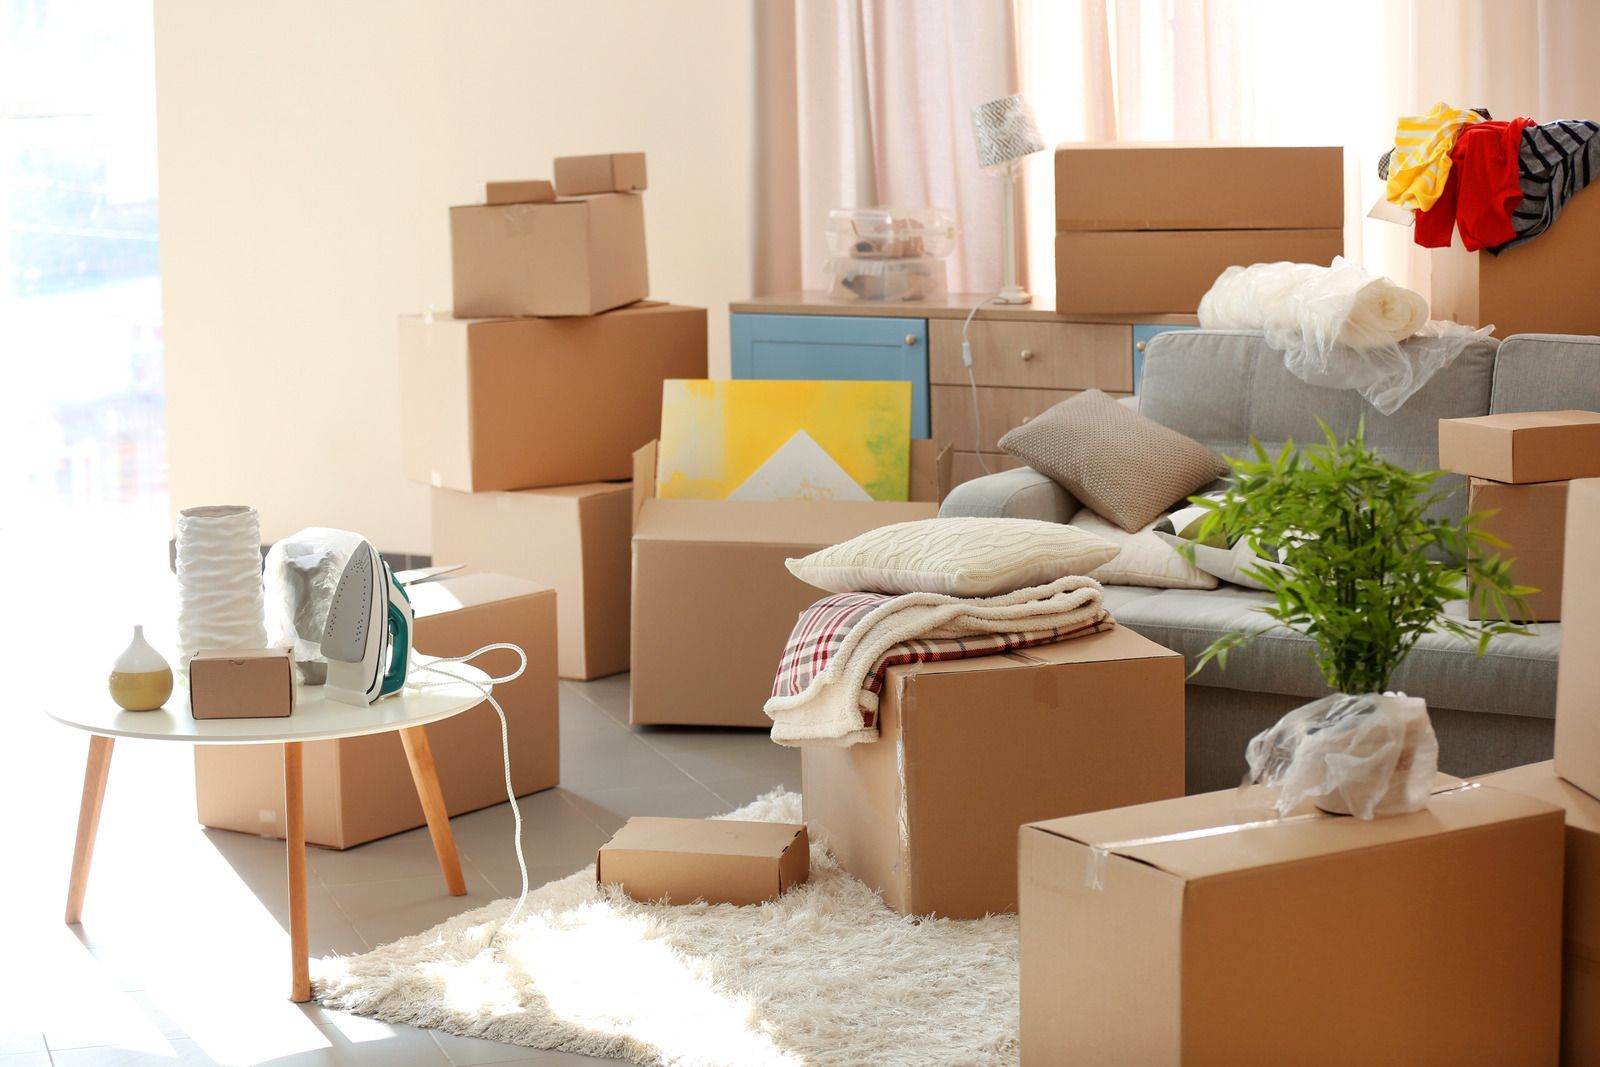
[312,792,1018,1067]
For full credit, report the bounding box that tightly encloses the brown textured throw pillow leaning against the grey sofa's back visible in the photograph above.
[1000,389,1227,531]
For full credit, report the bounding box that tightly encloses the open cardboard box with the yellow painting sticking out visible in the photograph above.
[629,440,950,726]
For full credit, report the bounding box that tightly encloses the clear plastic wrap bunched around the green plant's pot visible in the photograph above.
[1245,693,1438,819]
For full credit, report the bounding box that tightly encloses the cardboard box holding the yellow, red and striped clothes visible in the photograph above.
[1430,179,1600,338]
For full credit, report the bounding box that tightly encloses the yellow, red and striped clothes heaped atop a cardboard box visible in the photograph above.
[1378,104,1600,254]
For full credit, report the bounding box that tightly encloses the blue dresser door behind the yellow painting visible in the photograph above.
[731,315,928,437]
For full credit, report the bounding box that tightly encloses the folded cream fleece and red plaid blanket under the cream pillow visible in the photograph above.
[766,576,1114,745]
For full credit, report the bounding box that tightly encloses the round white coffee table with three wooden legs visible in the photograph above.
[48,664,490,1001]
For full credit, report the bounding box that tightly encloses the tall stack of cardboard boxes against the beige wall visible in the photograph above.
[412,154,706,678]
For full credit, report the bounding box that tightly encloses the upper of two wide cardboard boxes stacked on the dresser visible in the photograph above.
[1056,141,1344,230]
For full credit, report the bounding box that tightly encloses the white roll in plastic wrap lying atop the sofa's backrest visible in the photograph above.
[1198,256,1493,414]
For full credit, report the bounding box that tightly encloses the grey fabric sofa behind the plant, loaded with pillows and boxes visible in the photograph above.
[939,331,1600,792]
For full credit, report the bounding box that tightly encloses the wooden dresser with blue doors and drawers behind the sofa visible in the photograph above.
[730,293,1195,485]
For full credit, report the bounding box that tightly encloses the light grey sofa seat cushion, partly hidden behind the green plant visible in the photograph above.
[1106,585,1562,718]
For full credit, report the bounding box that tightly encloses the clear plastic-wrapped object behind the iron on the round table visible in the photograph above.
[262,526,362,685]
